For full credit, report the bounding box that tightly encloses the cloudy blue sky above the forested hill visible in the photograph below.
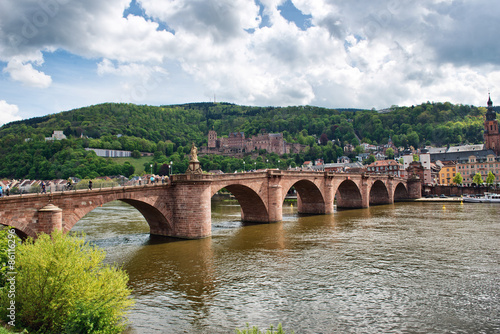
[0,0,500,124]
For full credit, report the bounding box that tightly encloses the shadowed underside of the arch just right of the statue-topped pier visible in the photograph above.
[212,184,269,223]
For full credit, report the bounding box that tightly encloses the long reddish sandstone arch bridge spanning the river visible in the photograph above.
[0,169,421,239]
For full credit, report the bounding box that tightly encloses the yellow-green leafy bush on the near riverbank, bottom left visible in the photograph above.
[0,231,133,334]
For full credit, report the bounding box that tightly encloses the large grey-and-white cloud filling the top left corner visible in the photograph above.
[0,0,172,62]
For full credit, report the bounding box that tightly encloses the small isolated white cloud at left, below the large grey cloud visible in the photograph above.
[3,57,52,88]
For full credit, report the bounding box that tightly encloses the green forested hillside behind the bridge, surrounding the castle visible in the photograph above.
[0,102,492,179]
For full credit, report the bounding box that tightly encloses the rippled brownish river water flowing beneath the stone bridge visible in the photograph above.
[73,201,500,334]
